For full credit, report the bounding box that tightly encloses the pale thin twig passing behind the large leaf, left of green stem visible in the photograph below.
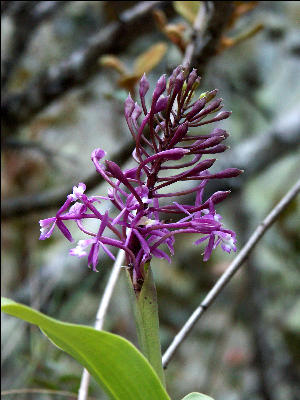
[78,250,124,400]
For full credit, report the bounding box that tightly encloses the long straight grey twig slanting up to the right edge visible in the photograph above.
[163,179,300,368]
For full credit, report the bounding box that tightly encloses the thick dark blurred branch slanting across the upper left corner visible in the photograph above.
[2,1,169,134]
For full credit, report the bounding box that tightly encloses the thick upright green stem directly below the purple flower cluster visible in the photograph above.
[127,264,165,385]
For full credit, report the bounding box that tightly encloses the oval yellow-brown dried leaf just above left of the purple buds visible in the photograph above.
[134,42,167,76]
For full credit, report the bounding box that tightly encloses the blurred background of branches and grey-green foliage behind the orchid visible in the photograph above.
[1,1,300,400]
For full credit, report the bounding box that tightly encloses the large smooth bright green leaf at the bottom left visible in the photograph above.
[1,298,169,400]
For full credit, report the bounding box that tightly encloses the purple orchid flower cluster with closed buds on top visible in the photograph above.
[40,66,242,289]
